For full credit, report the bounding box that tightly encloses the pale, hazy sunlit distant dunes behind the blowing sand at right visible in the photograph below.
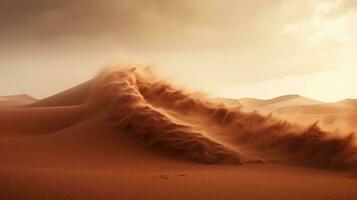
[234,95,357,133]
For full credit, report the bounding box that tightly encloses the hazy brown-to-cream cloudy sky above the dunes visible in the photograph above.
[0,0,357,101]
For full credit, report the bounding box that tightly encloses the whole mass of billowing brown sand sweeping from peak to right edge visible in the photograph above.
[84,67,357,169]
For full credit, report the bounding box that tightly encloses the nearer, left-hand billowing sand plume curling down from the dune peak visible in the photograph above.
[86,68,241,163]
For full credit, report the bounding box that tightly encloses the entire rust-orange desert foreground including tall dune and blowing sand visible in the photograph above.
[0,68,357,200]
